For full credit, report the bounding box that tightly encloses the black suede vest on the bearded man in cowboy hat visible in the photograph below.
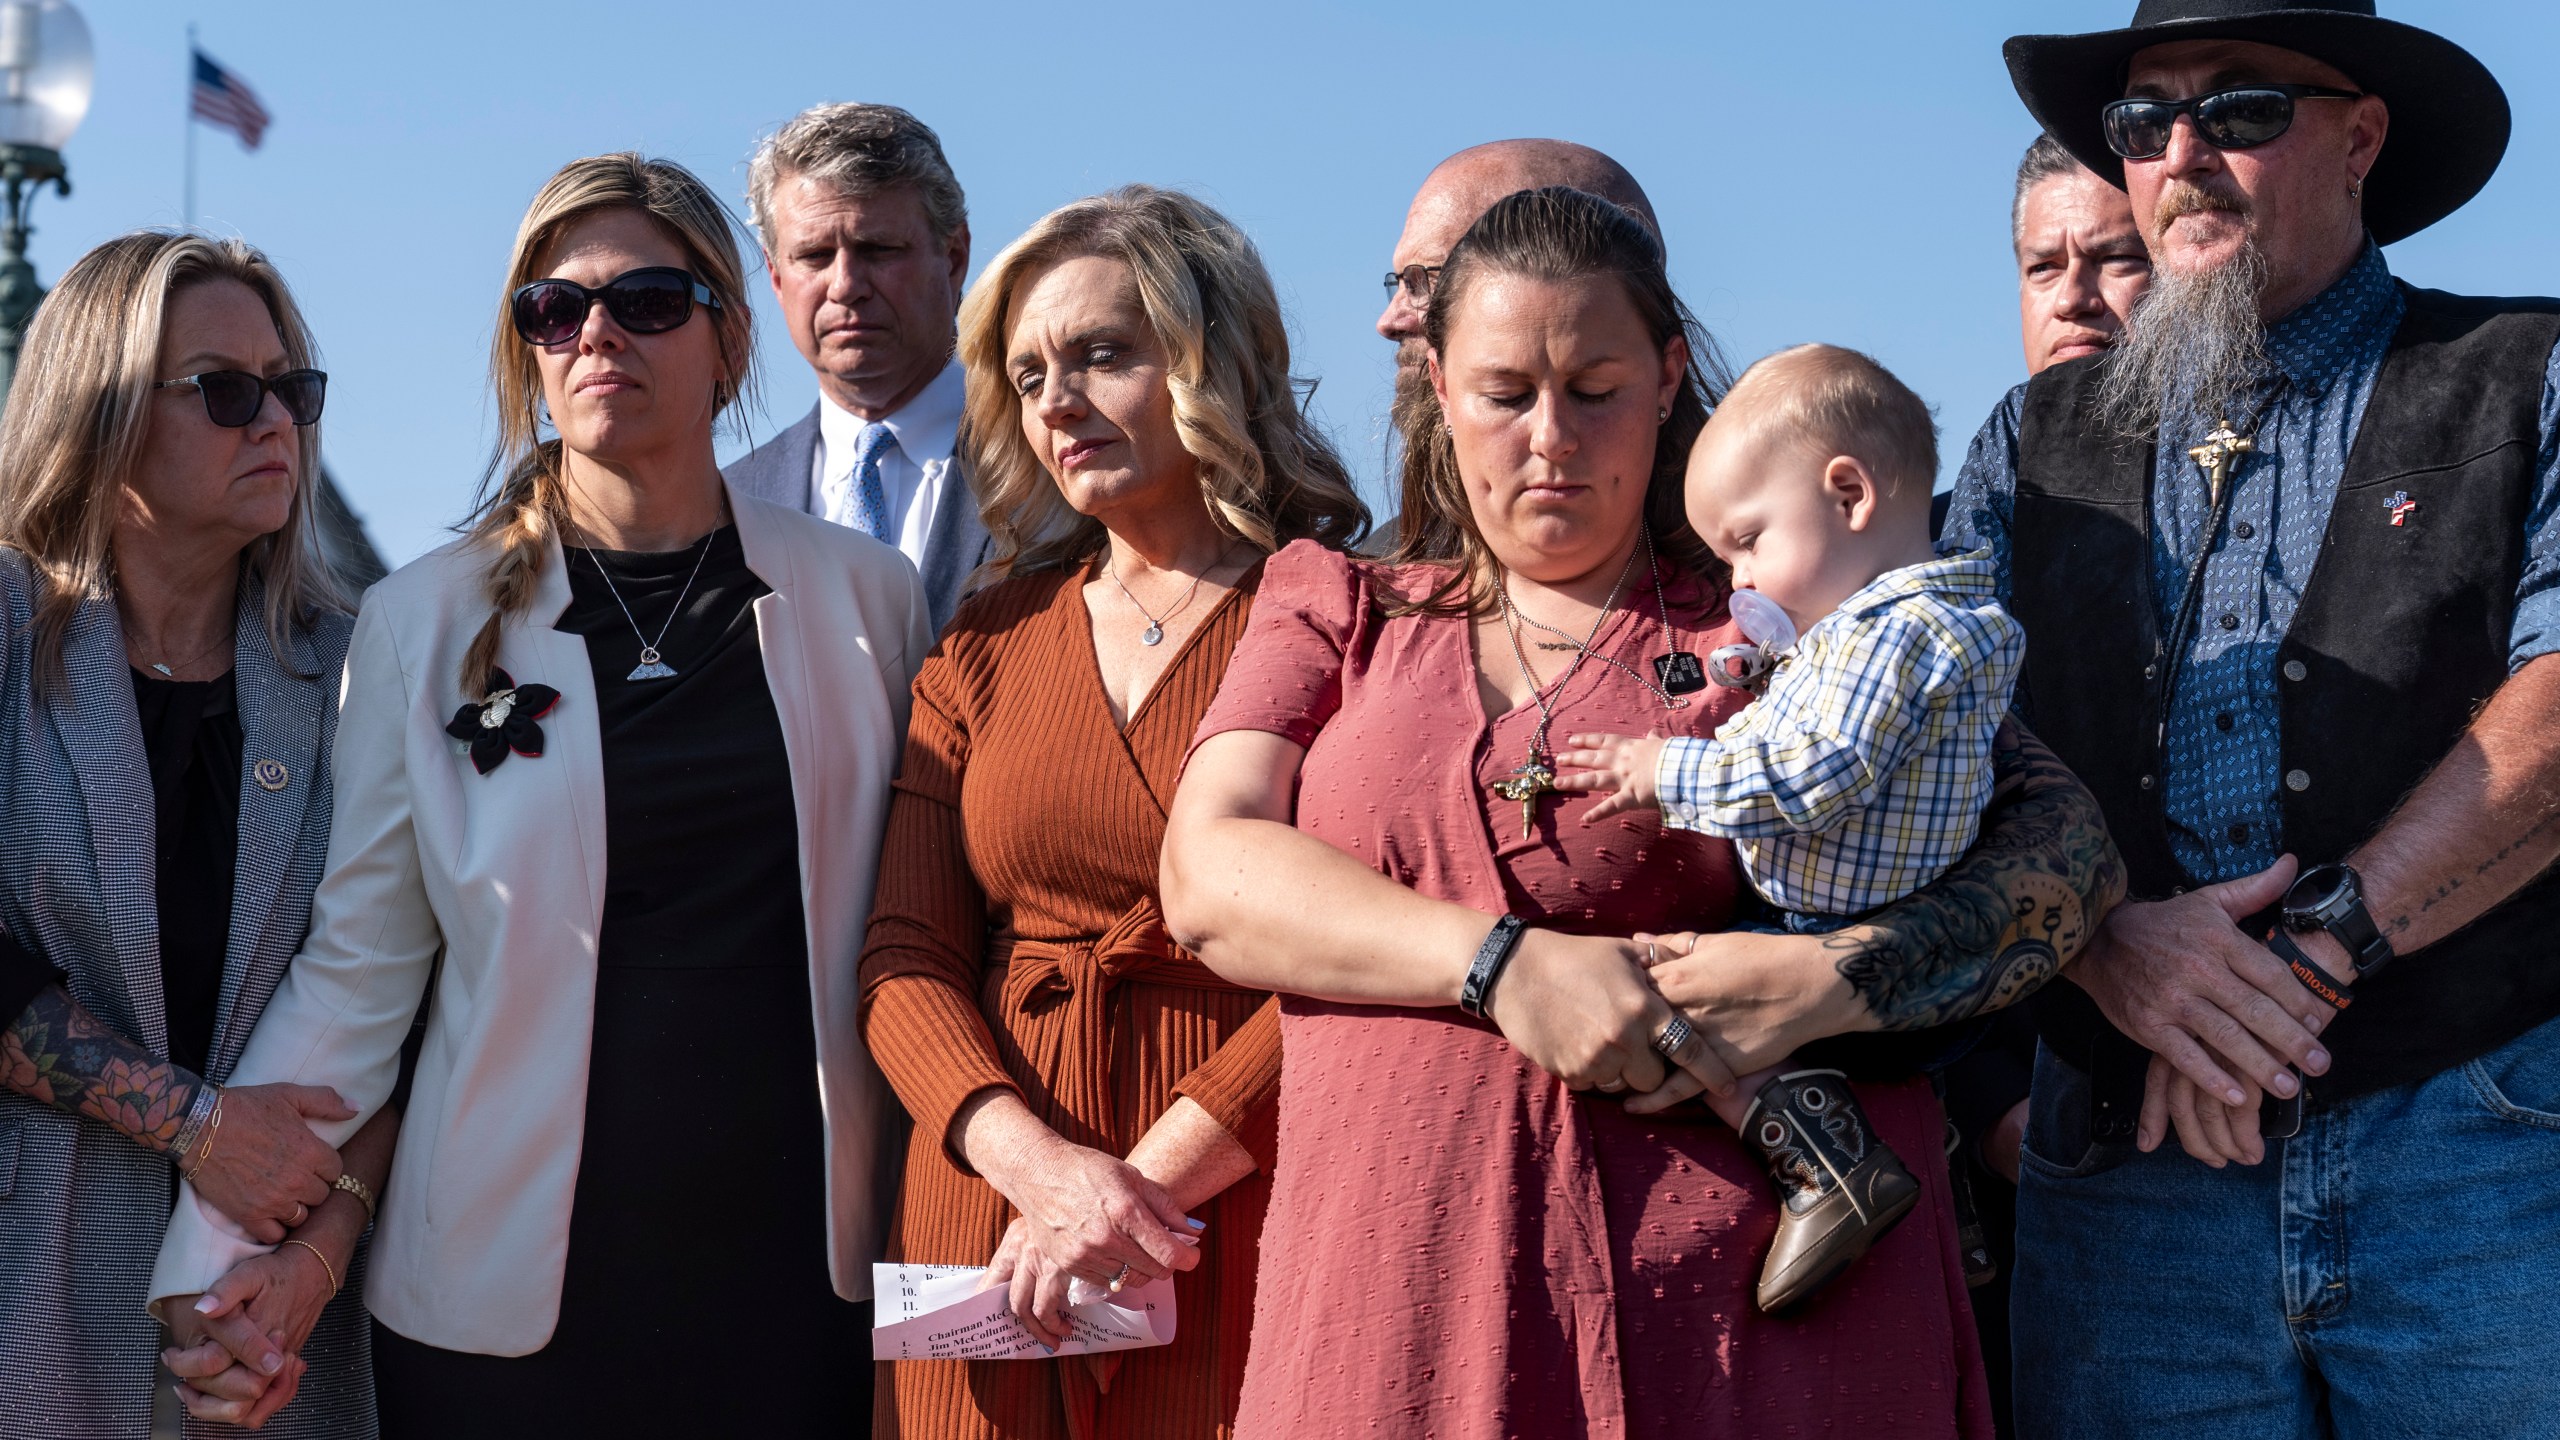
[2012,287,2560,1112]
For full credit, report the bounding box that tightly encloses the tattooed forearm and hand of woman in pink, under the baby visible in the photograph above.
[1631,720,2125,1081]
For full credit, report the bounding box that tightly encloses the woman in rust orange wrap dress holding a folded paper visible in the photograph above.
[863,187,1367,1440]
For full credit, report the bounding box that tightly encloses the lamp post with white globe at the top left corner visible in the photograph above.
[0,0,95,395]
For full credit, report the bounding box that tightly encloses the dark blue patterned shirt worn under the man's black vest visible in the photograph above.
[1940,243,2560,881]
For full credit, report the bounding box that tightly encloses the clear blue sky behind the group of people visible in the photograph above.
[33,0,2560,564]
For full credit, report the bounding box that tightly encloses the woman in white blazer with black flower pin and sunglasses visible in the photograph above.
[154,154,932,1437]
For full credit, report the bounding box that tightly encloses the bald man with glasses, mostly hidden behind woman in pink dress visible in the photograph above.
[1370,138,1661,553]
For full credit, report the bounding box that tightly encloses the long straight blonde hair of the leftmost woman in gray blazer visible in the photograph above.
[0,231,346,687]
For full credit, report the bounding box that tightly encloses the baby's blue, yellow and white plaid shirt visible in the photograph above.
[1654,551,2028,915]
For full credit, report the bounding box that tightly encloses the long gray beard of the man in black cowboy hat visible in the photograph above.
[2097,238,2268,443]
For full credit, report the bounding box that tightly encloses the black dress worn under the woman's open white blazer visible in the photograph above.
[374,528,870,1440]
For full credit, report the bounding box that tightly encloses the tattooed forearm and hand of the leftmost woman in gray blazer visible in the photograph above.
[0,984,353,1245]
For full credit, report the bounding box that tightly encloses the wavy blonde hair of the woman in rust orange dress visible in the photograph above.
[960,184,1370,577]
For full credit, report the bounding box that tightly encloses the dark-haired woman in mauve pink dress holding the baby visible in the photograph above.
[1165,190,2120,1440]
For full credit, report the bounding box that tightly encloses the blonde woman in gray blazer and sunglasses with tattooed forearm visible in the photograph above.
[0,231,397,1435]
